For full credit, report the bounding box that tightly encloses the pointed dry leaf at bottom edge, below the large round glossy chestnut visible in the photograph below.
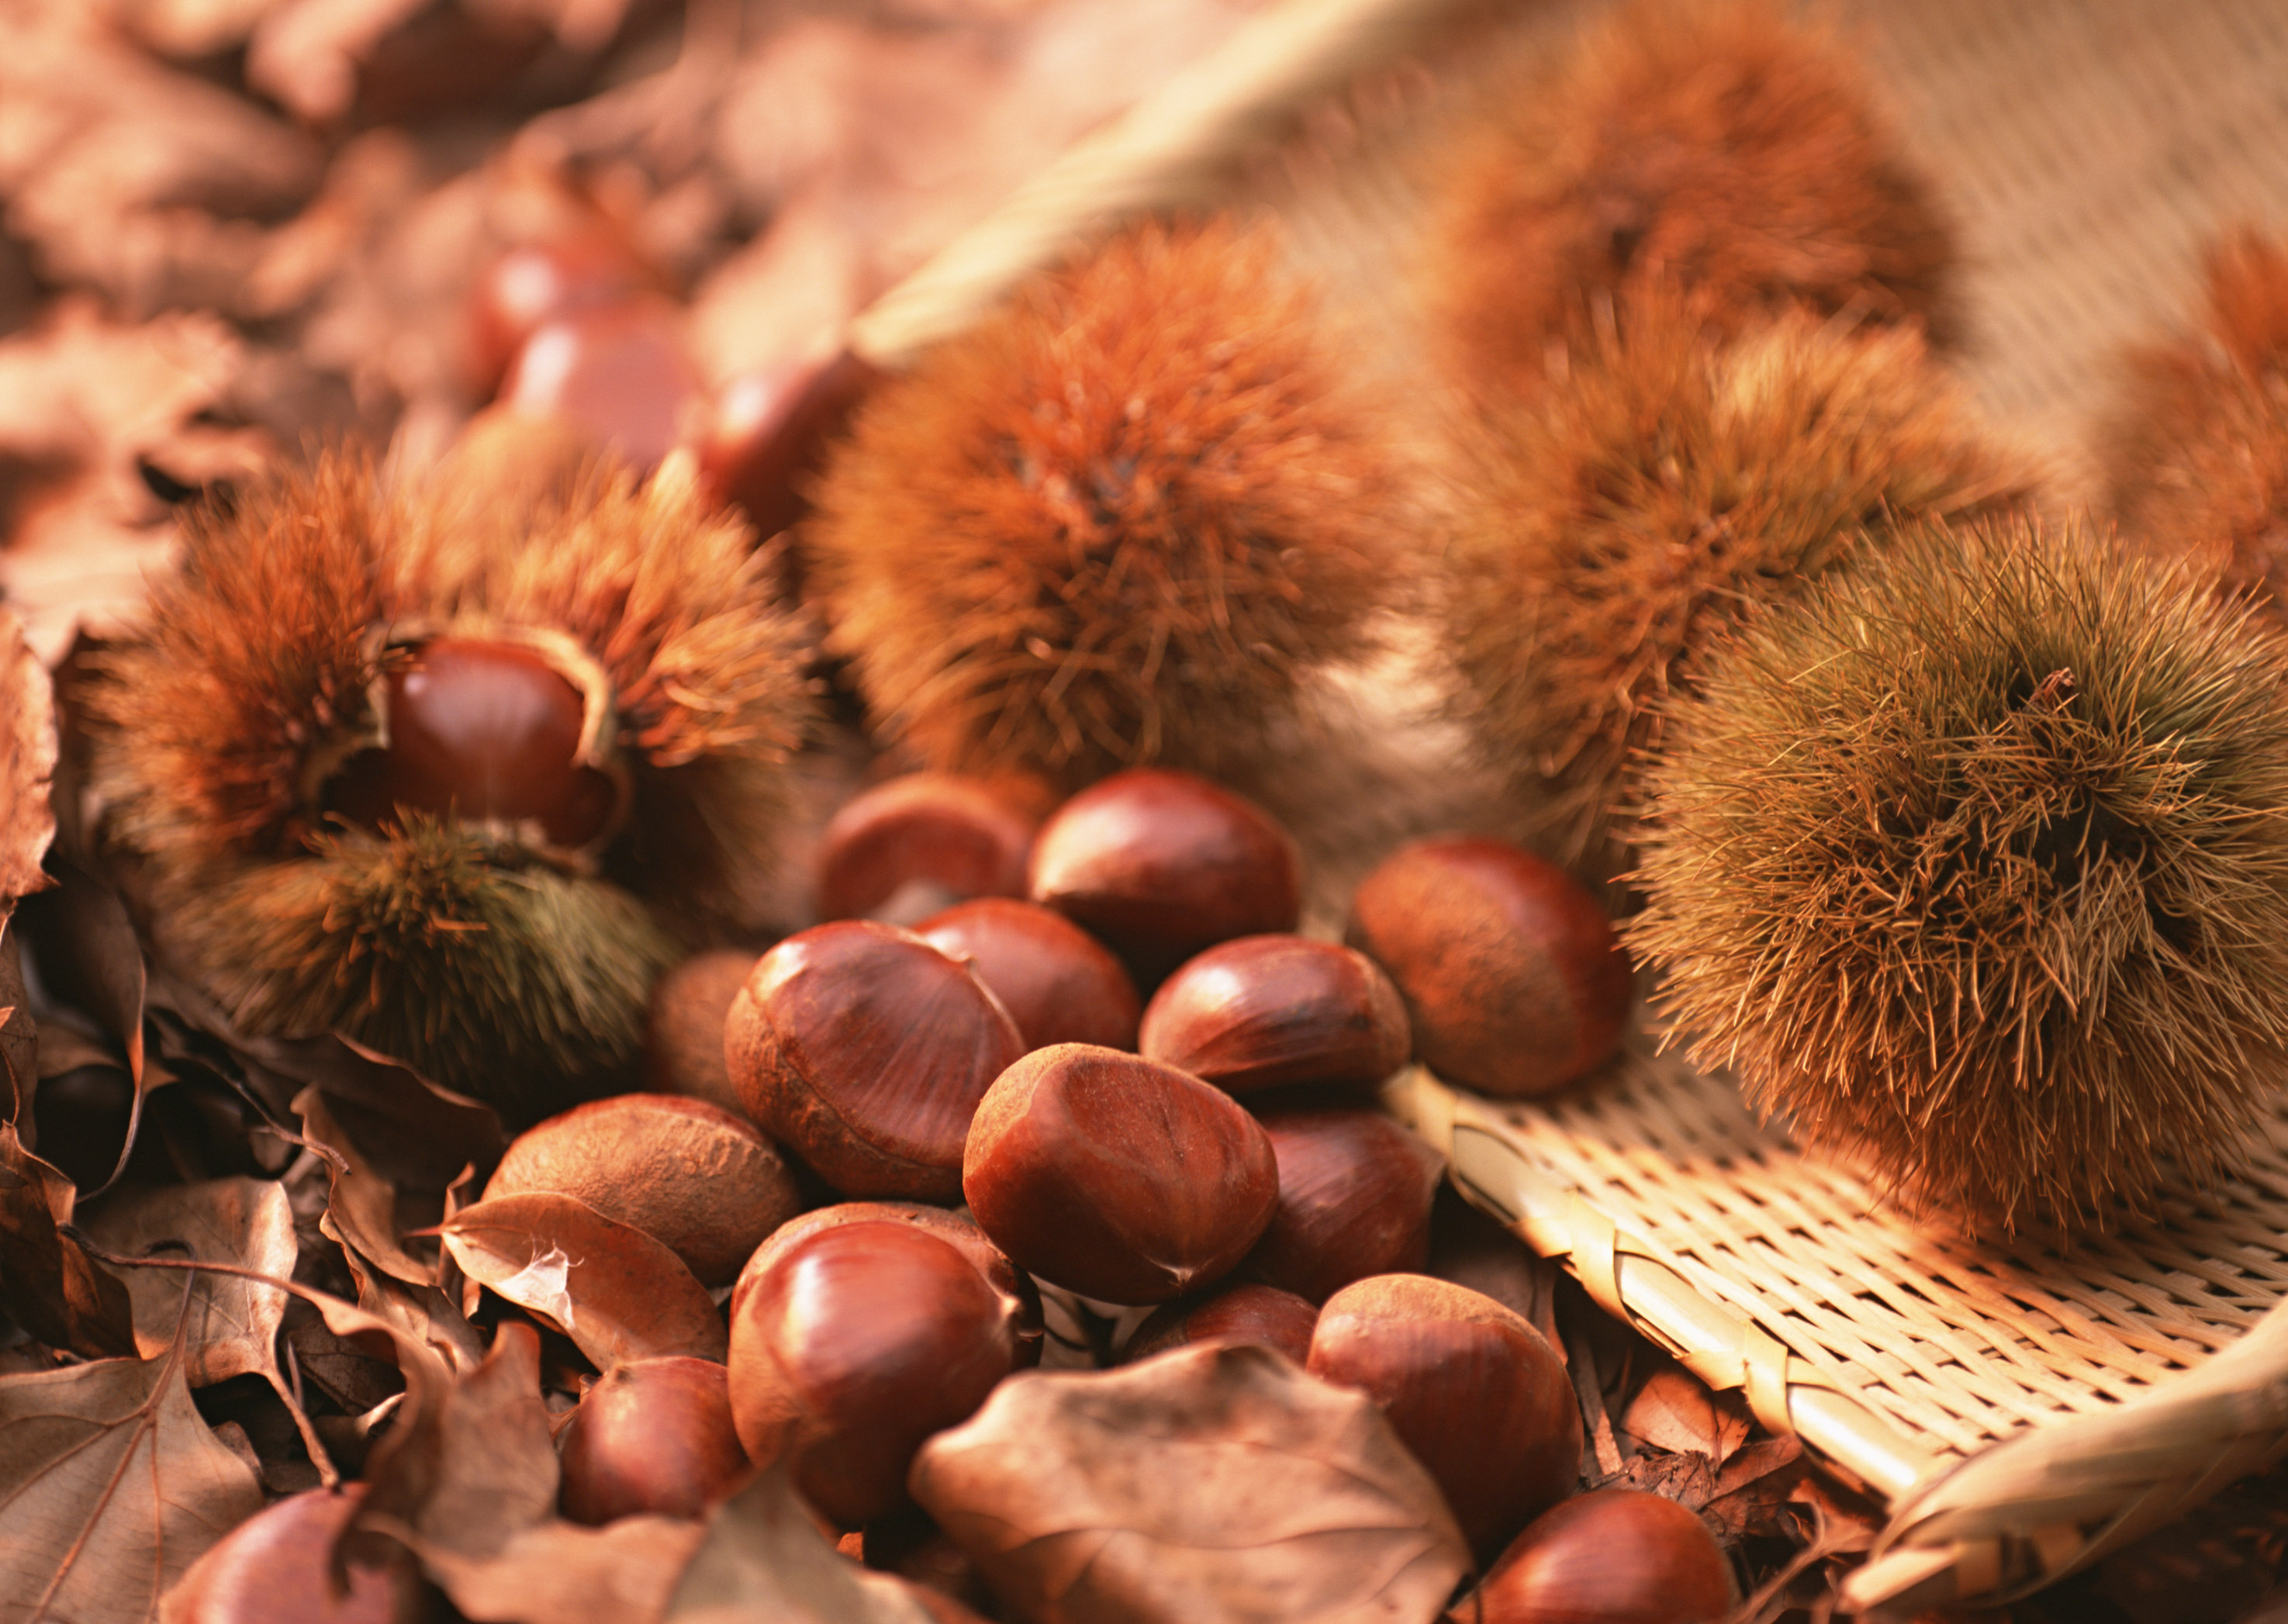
[665,1462,929,1624]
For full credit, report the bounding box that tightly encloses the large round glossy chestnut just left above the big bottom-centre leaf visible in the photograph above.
[730,1224,1016,1528]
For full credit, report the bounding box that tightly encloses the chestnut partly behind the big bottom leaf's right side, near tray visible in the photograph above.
[1306,1274,1581,1560]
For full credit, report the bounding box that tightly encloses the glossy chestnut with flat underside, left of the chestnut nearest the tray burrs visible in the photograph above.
[1137,935,1407,1094]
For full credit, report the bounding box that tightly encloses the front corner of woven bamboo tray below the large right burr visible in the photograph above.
[1384,1048,2288,1612]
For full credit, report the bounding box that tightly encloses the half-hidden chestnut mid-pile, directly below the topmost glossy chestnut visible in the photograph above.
[913,897,1137,1050]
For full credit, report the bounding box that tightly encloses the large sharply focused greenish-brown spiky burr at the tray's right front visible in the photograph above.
[1629,519,2288,1231]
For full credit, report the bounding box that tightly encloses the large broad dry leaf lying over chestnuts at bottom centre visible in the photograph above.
[911,1342,1469,1624]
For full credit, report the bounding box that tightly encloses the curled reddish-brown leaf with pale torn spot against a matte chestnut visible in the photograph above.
[439,1194,730,1368]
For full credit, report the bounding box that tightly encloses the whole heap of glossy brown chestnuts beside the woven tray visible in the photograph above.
[505,769,1730,1624]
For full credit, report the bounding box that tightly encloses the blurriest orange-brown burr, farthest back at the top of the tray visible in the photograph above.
[1426,0,1954,393]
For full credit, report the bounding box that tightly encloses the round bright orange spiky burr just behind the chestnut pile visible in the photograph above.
[805,224,1405,790]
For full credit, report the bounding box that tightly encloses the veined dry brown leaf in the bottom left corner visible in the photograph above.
[0,1349,263,1624]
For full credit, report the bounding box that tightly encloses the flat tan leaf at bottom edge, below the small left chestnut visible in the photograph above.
[407,1516,707,1624]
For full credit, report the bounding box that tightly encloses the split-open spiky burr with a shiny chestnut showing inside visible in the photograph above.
[87,455,812,1118]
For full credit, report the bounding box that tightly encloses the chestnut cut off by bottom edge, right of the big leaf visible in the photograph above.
[1457,1489,1732,1624]
